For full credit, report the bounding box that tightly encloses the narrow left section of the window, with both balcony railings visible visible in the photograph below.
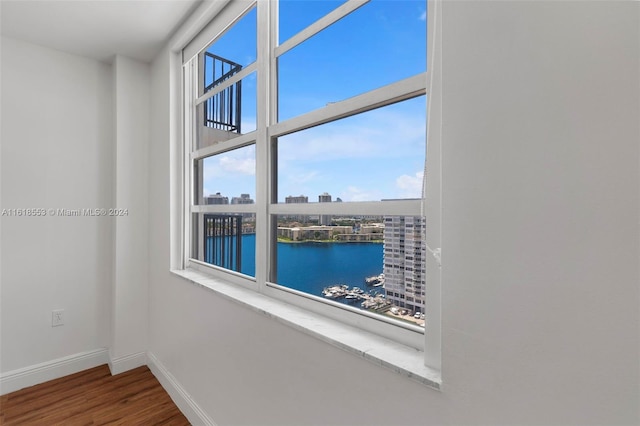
[184,5,257,279]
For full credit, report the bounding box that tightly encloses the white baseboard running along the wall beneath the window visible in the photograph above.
[147,352,216,426]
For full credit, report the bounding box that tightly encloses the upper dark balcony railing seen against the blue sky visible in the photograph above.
[204,52,242,133]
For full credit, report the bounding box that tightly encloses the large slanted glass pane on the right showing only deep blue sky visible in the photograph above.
[278,0,427,121]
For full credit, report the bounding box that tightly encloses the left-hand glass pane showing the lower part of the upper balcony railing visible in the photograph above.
[196,72,257,149]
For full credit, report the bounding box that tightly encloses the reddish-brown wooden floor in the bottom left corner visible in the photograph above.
[0,365,189,426]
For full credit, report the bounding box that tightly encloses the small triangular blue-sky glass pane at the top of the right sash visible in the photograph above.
[278,0,346,44]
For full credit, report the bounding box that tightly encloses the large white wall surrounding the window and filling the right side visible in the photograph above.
[149,1,640,425]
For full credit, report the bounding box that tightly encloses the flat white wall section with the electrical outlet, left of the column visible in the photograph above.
[0,37,113,373]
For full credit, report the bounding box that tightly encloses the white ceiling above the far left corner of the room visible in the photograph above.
[0,0,202,62]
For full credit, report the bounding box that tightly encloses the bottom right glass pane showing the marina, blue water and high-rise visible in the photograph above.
[275,215,425,325]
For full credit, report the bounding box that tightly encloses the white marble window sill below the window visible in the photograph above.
[171,269,441,390]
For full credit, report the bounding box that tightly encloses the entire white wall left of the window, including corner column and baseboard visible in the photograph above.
[0,37,150,386]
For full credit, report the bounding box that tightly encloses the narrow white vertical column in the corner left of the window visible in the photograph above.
[109,56,150,373]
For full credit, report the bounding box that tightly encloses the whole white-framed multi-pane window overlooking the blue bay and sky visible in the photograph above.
[183,0,429,348]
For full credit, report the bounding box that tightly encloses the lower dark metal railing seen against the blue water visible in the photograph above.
[203,214,242,272]
